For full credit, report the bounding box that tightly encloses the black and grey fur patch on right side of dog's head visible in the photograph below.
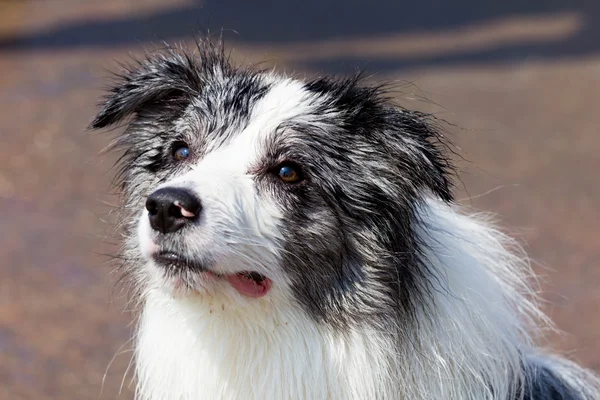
[252,77,452,332]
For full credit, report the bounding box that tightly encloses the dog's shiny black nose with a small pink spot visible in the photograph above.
[146,188,202,233]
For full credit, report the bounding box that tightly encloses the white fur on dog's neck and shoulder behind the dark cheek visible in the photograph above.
[401,200,545,400]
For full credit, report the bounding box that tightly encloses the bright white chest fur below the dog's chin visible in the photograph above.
[136,290,397,400]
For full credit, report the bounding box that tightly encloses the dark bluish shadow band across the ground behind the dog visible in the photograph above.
[0,0,600,72]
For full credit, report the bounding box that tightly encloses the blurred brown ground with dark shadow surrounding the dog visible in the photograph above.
[0,0,600,400]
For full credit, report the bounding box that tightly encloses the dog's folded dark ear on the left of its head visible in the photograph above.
[90,54,201,129]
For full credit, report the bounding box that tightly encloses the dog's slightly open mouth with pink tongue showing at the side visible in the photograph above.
[153,251,272,298]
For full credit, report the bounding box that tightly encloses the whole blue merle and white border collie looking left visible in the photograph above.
[91,40,600,400]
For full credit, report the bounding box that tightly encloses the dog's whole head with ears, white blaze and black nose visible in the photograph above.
[92,43,451,325]
